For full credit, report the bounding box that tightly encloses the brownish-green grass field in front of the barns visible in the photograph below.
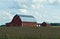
[0,27,60,39]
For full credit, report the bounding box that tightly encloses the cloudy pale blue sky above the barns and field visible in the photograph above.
[0,0,60,25]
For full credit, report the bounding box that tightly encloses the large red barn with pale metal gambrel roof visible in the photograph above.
[6,14,37,27]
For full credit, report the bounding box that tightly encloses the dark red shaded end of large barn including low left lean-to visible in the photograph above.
[6,15,22,27]
